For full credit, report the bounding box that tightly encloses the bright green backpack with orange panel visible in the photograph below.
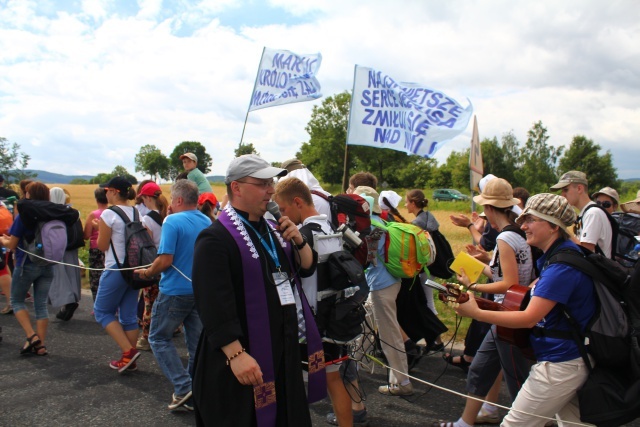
[371,219,436,278]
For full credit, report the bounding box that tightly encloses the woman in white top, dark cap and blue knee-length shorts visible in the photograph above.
[93,176,140,373]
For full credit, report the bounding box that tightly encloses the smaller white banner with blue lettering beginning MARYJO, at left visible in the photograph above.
[249,48,322,111]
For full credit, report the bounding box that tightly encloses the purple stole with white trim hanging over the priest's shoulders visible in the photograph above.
[218,204,327,427]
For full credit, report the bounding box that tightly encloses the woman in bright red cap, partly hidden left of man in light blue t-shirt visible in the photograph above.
[136,182,168,351]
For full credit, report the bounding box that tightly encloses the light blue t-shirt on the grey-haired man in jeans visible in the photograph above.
[158,209,211,295]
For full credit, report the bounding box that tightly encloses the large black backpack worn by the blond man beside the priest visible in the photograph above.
[300,223,369,343]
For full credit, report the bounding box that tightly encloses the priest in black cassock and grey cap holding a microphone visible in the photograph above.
[193,154,326,427]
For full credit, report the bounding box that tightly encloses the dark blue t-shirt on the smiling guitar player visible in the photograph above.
[531,240,596,362]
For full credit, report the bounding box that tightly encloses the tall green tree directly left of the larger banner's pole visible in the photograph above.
[296,92,355,184]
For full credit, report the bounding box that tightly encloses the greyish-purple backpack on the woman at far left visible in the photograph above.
[22,220,67,266]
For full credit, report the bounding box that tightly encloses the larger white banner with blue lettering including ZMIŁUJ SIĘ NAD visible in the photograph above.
[347,65,473,158]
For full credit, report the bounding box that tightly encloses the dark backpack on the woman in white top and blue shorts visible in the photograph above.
[109,206,158,289]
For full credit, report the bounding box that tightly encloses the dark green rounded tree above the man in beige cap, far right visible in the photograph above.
[558,135,620,191]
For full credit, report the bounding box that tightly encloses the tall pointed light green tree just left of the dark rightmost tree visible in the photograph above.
[512,121,563,194]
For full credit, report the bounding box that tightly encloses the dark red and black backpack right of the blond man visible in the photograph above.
[311,190,371,267]
